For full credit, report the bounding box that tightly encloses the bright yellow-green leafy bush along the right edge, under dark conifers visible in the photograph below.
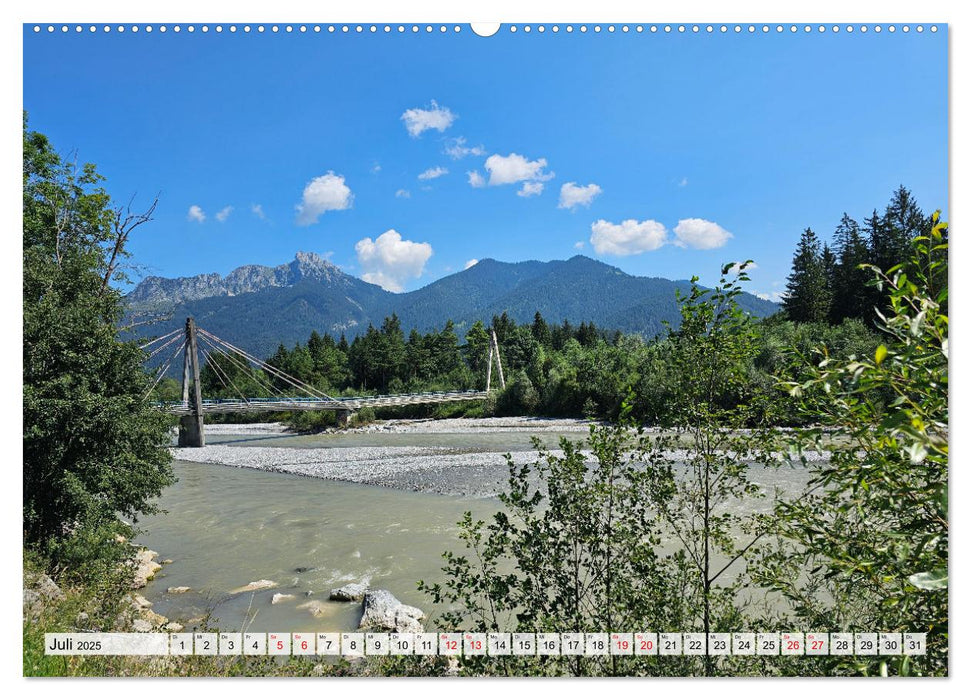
[760,214,949,674]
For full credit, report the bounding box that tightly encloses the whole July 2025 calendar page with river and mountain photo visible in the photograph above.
[20,0,948,679]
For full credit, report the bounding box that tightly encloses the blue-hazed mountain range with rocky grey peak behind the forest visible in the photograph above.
[126,252,778,357]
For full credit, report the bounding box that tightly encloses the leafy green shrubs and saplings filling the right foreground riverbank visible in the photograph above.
[421,215,949,675]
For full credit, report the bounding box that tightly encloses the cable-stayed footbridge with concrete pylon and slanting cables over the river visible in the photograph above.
[147,318,506,447]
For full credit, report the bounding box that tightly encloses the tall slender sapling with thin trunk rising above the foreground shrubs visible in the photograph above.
[642,263,776,675]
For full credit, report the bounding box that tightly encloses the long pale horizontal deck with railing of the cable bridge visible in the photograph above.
[162,391,490,416]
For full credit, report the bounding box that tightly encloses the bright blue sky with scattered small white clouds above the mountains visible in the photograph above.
[24,25,947,296]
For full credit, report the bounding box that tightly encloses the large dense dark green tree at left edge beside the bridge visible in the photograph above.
[23,122,173,566]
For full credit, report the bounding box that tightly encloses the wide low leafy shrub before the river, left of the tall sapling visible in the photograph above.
[419,418,681,675]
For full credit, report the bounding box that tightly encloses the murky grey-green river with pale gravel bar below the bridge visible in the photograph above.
[138,419,803,632]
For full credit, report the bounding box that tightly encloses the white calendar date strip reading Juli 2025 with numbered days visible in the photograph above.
[44,632,927,657]
